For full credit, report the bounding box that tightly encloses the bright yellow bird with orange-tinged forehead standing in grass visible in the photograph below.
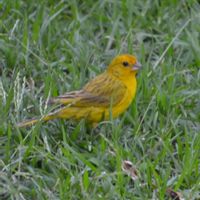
[18,54,141,127]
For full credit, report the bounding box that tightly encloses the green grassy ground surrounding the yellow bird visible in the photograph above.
[0,0,200,200]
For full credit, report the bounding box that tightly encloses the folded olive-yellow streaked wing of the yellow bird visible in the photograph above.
[49,73,127,107]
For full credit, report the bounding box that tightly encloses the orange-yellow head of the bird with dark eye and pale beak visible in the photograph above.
[108,54,142,79]
